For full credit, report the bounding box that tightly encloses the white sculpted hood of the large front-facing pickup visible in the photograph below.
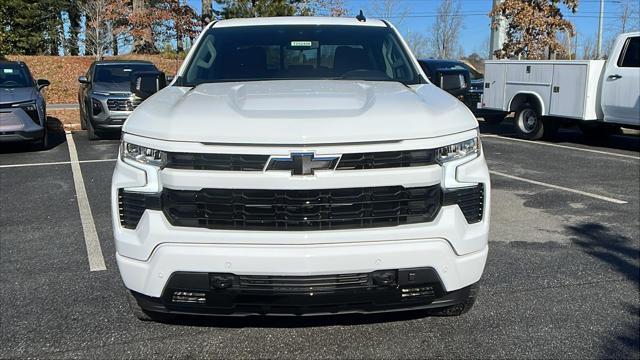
[123,80,478,145]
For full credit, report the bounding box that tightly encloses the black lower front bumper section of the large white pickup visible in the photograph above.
[133,268,477,316]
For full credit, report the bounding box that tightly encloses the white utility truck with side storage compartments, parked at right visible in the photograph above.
[482,32,640,140]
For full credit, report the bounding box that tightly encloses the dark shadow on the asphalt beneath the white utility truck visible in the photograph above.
[478,118,640,152]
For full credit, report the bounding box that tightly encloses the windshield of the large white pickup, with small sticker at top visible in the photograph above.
[180,25,419,86]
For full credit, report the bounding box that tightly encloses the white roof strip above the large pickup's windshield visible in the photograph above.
[211,16,387,28]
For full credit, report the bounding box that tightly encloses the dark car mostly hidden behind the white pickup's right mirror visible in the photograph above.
[418,59,507,124]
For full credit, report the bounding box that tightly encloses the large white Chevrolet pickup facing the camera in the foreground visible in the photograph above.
[112,17,490,318]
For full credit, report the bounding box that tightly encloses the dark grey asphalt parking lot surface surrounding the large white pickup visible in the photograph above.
[0,124,640,358]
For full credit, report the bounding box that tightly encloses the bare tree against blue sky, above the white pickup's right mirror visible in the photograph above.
[431,0,463,59]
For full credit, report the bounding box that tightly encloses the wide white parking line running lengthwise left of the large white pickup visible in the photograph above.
[67,132,107,271]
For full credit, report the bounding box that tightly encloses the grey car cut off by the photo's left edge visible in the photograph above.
[0,61,49,149]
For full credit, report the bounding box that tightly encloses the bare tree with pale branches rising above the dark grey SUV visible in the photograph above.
[78,0,111,60]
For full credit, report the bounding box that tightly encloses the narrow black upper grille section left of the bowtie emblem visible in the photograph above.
[166,153,269,171]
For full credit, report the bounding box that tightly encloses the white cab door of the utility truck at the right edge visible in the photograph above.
[601,33,640,125]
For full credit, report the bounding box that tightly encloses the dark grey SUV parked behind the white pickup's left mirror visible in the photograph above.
[78,60,158,140]
